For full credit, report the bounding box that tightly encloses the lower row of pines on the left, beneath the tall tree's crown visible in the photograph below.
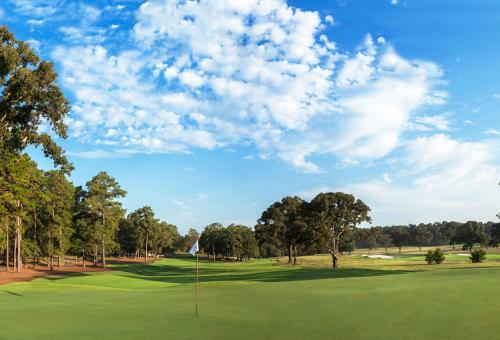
[0,162,180,271]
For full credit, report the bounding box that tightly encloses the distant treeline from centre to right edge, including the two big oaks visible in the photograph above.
[200,197,500,267]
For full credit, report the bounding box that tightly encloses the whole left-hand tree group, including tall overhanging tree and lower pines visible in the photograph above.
[0,26,182,271]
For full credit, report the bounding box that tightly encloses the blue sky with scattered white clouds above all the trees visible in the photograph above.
[0,0,500,231]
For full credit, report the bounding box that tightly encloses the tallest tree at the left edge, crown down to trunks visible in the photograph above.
[0,26,72,271]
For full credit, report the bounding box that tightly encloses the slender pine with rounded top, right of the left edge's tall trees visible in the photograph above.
[85,172,126,268]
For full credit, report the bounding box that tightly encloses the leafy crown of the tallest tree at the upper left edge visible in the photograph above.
[0,26,72,172]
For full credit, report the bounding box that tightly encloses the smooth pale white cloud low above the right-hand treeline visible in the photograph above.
[298,134,500,225]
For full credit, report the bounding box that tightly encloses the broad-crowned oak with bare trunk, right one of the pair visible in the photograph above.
[310,192,371,268]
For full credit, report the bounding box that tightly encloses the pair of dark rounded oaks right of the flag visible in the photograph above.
[255,192,371,268]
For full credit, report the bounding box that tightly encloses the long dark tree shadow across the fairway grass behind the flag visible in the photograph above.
[111,260,408,284]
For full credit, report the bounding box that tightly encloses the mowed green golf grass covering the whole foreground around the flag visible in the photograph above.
[0,254,500,339]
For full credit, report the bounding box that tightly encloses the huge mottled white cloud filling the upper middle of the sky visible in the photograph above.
[47,0,446,173]
